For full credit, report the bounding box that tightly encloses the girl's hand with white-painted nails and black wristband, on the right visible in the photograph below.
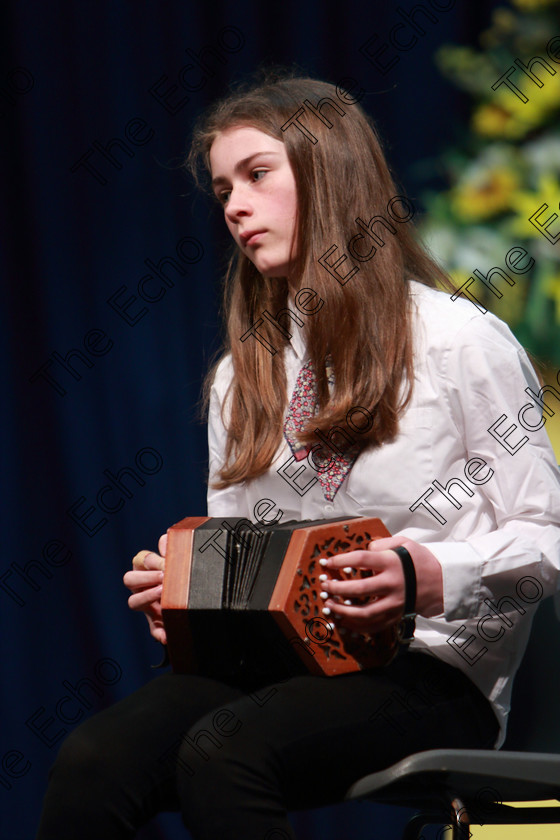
[322,535,443,635]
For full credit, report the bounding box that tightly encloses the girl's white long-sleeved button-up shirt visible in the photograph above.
[208,281,560,746]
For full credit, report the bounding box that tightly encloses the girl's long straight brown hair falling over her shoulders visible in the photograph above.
[186,76,451,489]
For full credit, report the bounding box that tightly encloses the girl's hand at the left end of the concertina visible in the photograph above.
[123,534,167,645]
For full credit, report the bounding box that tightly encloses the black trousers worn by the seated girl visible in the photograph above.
[37,652,498,840]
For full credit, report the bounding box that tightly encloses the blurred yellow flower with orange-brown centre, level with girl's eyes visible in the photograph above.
[451,167,519,222]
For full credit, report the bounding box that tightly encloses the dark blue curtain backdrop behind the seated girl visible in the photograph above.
[0,0,504,840]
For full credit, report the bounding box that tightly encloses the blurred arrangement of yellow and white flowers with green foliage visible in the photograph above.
[420,0,560,367]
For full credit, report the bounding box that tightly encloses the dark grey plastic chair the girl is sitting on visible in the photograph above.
[345,598,560,840]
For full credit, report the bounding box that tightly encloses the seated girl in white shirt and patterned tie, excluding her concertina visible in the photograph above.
[38,77,560,840]
